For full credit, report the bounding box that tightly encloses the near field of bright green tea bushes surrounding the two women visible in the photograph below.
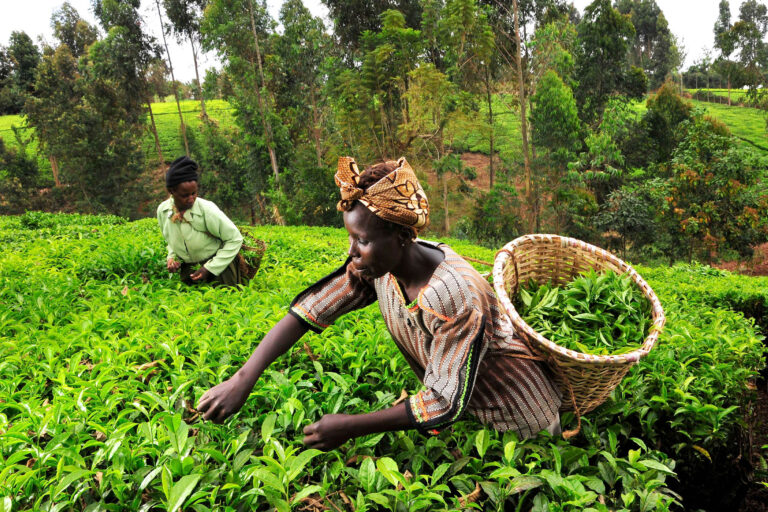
[0,214,766,511]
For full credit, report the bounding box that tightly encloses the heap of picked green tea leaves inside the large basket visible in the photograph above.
[515,270,651,355]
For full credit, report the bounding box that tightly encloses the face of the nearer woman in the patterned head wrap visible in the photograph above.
[344,203,403,279]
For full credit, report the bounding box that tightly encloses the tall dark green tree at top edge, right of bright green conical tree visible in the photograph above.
[574,0,646,124]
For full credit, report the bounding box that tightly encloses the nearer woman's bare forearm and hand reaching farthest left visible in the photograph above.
[197,315,307,423]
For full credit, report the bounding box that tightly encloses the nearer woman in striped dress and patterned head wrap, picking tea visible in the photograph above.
[198,158,561,450]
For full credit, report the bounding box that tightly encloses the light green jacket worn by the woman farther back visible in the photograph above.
[157,197,243,276]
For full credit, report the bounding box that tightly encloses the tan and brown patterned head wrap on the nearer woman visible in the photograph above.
[334,156,429,234]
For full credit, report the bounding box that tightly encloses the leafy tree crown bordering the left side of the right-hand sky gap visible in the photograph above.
[615,0,682,89]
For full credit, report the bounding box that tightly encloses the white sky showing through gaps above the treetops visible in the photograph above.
[0,0,756,82]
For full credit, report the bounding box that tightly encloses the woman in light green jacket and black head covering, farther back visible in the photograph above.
[157,156,247,286]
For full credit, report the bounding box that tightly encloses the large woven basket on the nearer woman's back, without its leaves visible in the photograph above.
[493,234,665,425]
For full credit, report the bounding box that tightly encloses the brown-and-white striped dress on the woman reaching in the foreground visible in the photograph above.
[290,240,561,438]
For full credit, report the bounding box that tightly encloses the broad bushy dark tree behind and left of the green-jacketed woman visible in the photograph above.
[26,41,144,215]
